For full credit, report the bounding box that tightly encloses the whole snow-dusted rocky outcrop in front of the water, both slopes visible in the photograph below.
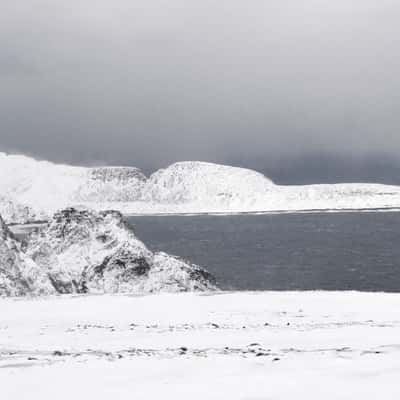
[0,209,217,296]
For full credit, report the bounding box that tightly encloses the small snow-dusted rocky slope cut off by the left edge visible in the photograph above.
[0,216,56,296]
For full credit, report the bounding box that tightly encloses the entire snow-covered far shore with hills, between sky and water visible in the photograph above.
[0,153,400,223]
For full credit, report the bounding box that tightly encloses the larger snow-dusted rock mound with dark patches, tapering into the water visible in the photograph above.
[27,208,216,293]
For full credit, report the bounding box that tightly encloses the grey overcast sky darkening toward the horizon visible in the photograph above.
[0,0,400,183]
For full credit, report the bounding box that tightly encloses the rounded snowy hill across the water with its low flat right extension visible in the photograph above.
[142,162,400,213]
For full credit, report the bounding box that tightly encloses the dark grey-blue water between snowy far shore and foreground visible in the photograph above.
[128,213,400,292]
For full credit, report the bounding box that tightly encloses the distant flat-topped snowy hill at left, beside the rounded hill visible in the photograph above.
[0,153,146,220]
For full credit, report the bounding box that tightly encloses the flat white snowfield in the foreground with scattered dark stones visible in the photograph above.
[0,292,400,400]
